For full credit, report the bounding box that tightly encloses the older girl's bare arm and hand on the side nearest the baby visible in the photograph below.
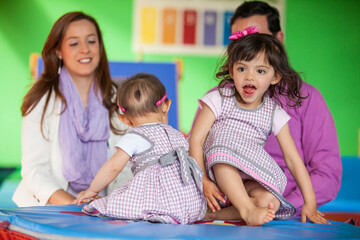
[189,104,225,212]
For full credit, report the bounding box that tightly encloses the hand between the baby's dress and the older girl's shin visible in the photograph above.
[203,176,226,212]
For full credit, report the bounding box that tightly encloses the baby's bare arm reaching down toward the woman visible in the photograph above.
[77,148,130,205]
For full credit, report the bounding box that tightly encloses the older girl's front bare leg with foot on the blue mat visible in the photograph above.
[213,164,275,226]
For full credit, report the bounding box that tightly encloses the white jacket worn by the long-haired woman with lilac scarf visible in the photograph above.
[12,92,132,207]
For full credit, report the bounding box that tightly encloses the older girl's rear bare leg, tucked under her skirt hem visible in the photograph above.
[244,180,280,212]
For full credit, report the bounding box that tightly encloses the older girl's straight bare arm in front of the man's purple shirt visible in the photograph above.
[276,123,330,224]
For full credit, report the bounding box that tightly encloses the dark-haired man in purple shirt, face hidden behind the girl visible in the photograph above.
[191,1,342,215]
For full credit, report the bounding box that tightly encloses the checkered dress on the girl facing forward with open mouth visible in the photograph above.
[204,88,296,219]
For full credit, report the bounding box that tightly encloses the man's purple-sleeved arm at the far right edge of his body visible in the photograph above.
[302,86,342,207]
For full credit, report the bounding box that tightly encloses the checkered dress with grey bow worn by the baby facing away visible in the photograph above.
[83,123,206,224]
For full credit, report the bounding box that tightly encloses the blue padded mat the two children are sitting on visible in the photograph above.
[0,205,360,239]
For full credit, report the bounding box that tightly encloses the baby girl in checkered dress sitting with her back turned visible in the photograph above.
[77,73,206,224]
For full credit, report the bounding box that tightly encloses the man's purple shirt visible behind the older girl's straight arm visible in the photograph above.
[265,83,342,213]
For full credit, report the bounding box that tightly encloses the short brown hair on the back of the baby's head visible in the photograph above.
[117,73,168,117]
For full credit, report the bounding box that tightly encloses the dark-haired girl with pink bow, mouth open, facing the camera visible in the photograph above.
[189,27,328,225]
